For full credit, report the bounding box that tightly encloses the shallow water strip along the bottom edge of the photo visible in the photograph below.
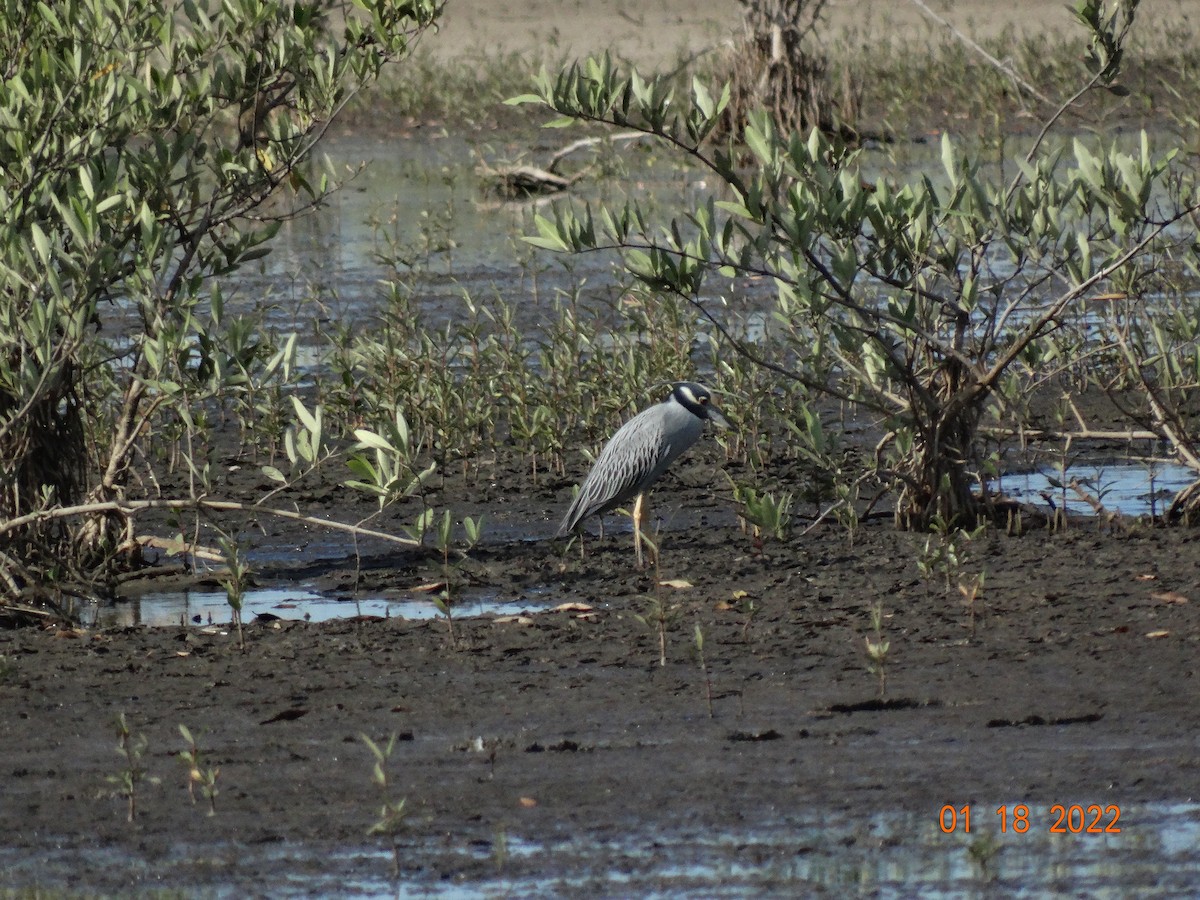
[0,802,1200,898]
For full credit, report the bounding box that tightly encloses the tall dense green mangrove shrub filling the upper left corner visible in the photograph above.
[0,0,440,607]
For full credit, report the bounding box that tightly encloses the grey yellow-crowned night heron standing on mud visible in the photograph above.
[554,382,730,568]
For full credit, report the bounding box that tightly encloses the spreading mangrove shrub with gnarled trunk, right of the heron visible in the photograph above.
[514,0,1195,528]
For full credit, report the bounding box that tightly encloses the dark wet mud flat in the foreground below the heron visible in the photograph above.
[0,488,1200,895]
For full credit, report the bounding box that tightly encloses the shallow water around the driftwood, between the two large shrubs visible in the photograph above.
[227,128,724,332]
